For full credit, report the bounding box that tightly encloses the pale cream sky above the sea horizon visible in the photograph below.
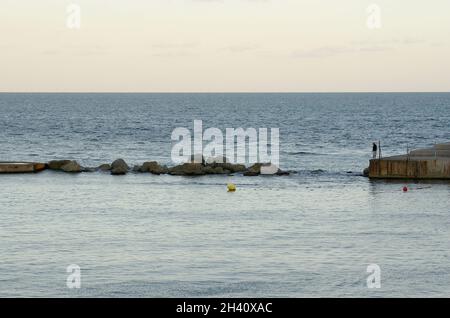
[0,0,450,92]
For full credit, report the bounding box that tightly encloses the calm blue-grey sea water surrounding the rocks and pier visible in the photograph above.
[0,94,450,297]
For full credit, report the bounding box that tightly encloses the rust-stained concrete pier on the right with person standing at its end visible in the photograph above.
[369,143,450,180]
